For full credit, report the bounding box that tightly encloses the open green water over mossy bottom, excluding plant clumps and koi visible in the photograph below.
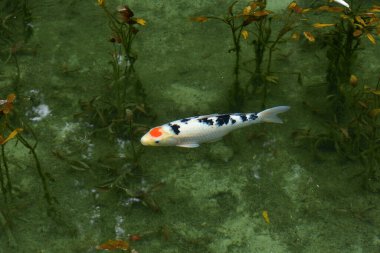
[0,0,380,253]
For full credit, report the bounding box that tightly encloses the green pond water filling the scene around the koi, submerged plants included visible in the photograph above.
[0,0,380,253]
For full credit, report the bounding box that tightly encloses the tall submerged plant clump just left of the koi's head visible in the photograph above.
[78,0,159,211]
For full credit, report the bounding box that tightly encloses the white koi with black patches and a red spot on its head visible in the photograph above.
[141,106,290,148]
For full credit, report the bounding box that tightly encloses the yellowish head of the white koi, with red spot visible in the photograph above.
[141,126,177,146]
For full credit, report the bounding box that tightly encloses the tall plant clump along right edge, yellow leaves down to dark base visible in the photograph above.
[294,1,380,192]
